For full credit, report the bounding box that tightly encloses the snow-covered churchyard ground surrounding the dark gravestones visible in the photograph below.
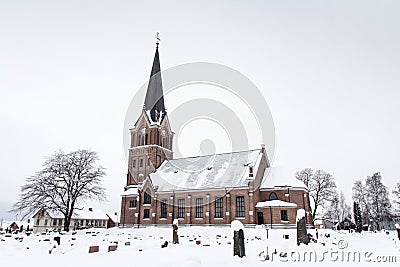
[0,226,400,267]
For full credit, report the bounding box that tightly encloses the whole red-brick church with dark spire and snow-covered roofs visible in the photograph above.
[120,42,312,228]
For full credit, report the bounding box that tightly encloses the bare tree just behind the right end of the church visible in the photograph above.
[296,168,337,222]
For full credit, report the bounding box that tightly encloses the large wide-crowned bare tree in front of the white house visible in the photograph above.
[12,150,105,231]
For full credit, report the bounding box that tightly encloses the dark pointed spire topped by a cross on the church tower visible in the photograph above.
[143,33,166,123]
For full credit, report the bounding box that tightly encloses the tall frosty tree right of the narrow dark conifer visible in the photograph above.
[365,172,391,230]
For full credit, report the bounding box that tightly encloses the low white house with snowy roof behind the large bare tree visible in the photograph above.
[33,208,109,233]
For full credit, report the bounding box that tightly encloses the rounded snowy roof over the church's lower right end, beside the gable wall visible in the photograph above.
[260,167,306,189]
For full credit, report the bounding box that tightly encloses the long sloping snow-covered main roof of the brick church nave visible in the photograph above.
[149,149,263,192]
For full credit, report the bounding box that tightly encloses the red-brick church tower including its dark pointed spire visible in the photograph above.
[126,38,174,188]
